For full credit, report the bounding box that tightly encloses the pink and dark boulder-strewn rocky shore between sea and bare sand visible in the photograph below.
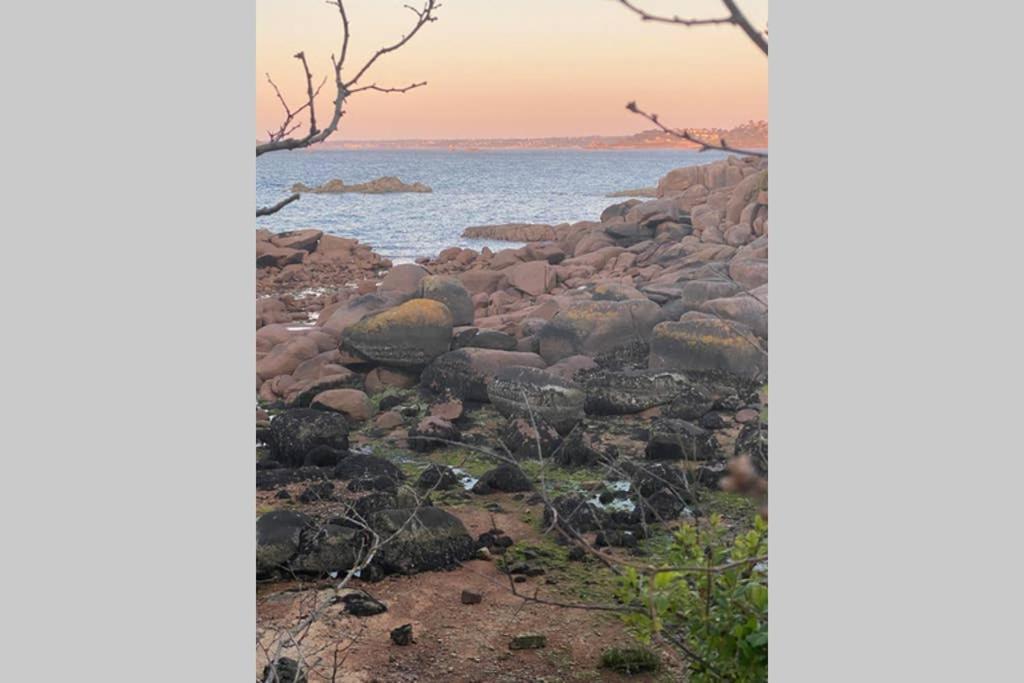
[256,157,768,680]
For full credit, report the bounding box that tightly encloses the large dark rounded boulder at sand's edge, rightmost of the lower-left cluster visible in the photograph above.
[368,507,477,573]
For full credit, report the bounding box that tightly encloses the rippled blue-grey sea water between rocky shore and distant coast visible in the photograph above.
[256,150,737,262]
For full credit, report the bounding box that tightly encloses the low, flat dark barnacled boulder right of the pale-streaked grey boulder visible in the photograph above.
[582,370,690,415]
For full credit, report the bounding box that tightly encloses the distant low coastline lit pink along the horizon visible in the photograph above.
[256,121,768,153]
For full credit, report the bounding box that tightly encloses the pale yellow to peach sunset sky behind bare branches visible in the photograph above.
[256,0,768,140]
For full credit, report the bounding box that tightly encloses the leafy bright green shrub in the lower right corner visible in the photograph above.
[618,515,768,683]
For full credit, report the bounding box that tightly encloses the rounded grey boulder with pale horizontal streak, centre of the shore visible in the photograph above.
[487,368,586,434]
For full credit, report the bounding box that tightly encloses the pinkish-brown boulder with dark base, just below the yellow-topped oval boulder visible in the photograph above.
[421,348,545,401]
